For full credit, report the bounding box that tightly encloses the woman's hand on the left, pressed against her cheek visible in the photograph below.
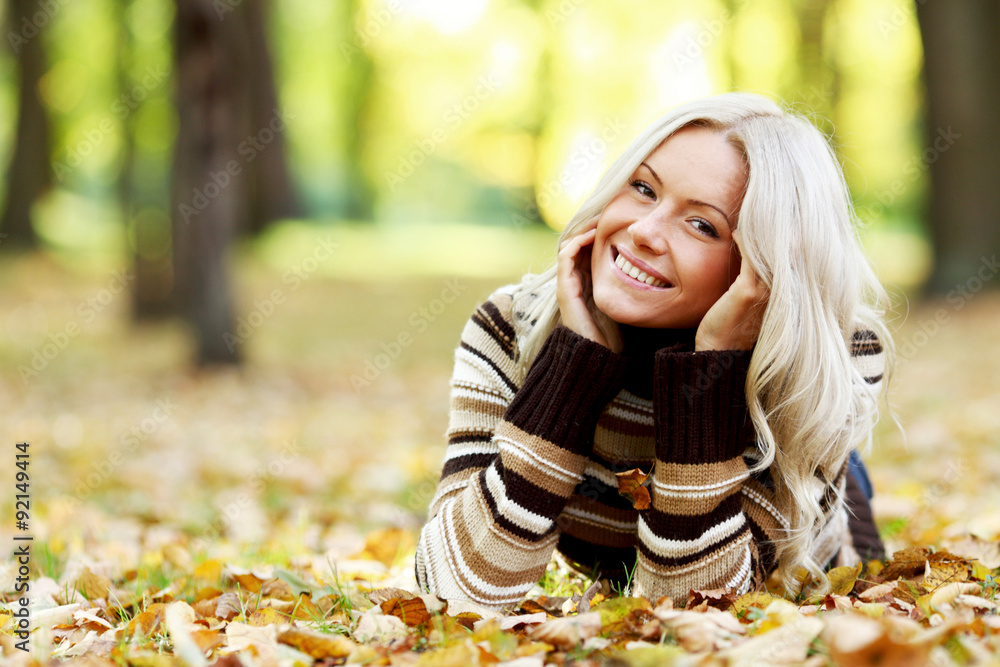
[556,220,621,352]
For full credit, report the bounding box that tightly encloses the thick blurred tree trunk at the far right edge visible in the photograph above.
[916,0,1000,294]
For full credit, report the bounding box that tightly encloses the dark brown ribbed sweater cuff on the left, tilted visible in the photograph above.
[504,324,626,455]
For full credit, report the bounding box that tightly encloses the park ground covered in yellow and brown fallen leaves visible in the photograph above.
[0,246,1000,667]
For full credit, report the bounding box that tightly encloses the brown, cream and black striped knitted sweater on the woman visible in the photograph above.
[415,286,884,609]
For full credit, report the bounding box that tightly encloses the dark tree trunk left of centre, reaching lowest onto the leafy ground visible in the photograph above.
[171,0,251,365]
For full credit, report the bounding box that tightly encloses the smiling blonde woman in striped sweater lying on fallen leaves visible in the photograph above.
[416,93,890,608]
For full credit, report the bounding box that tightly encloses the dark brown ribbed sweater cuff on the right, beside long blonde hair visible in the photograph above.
[653,348,752,464]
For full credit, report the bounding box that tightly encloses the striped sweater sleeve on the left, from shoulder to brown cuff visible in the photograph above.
[415,296,625,609]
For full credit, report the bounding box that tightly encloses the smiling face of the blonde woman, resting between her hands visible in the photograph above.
[591,127,747,329]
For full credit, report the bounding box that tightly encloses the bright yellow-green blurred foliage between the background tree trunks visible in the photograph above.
[0,0,929,285]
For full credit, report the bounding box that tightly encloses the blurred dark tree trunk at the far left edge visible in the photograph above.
[0,0,52,247]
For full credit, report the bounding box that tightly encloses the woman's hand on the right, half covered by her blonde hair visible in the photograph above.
[694,233,770,350]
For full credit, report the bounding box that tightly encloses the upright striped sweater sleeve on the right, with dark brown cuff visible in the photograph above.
[635,349,755,600]
